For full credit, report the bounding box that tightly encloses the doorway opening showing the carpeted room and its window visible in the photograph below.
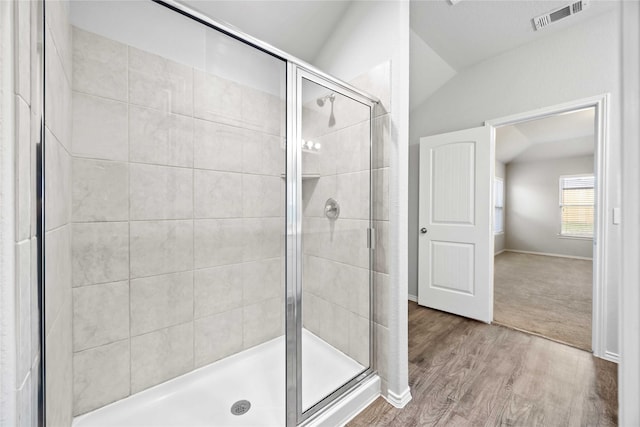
[493,107,596,351]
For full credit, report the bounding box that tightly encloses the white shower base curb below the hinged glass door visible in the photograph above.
[301,375,380,427]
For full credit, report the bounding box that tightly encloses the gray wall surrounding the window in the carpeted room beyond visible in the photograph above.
[505,156,593,258]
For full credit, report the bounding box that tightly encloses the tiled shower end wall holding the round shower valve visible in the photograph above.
[302,63,390,373]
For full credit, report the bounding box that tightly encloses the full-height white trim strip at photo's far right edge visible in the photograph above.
[618,1,640,426]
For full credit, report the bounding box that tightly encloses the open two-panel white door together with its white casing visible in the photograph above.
[418,94,608,361]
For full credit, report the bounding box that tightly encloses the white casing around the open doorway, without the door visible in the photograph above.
[485,93,608,357]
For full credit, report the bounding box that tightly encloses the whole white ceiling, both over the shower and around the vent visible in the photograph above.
[180,0,615,113]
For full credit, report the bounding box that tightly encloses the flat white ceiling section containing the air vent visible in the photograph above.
[411,0,616,71]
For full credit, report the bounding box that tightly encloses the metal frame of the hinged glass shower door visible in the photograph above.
[285,67,379,427]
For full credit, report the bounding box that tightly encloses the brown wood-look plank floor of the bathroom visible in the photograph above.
[348,302,618,427]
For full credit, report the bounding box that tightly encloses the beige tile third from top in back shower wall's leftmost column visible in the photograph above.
[72,157,129,222]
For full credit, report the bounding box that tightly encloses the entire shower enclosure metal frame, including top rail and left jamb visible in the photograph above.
[36,0,379,427]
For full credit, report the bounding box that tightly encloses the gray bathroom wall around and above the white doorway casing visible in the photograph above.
[408,10,620,354]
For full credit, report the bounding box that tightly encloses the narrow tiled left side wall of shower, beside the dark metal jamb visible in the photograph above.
[44,1,73,426]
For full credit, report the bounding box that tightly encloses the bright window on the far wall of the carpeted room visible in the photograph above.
[560,175,594,238]
